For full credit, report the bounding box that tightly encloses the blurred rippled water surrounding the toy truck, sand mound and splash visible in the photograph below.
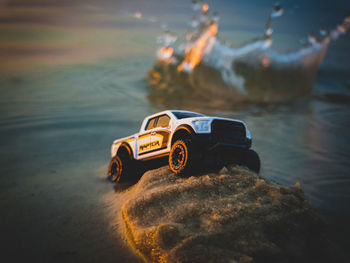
[0,0,350,262]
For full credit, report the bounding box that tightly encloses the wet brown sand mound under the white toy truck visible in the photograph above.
[122,167,327,263]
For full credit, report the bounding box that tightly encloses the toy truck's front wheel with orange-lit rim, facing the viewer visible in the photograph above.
[168,140,193,174]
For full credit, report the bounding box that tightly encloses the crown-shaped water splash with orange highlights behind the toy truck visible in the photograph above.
[149,1,350,104]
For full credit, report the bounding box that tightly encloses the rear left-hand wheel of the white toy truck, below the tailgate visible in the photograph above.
[108,155,135,183]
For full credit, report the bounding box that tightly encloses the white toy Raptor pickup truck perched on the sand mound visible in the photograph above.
[108,110,260,182]
